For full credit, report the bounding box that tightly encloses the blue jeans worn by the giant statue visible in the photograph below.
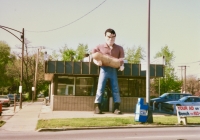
[94,66,121,103]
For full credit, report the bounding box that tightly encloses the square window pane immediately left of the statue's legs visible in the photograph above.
[76,77,94,96]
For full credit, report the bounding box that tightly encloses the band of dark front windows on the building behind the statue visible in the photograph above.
[57,76,146,97]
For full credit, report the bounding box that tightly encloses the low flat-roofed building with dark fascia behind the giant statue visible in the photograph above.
[45,61,164,112]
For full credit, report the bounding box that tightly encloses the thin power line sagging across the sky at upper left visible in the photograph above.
[26,0,106,33]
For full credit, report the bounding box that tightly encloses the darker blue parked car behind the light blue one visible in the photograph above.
[150,93,192,109]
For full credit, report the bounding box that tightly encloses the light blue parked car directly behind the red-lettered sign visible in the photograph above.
[161,96,200,111]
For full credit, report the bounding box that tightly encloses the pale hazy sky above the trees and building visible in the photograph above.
[0,0,200,79]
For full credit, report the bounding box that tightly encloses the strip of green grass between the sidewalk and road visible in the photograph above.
[36,116,200,129]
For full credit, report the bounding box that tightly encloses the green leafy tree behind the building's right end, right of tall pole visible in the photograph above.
[151,46,182,94]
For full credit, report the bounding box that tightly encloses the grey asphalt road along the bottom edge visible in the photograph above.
[0,127,200,140]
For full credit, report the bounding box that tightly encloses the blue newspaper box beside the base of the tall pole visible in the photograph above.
[135,98,148,123]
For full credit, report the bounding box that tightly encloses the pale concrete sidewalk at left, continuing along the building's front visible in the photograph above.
[0,102,165,132]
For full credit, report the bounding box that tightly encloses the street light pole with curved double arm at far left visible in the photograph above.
[0,25,24,109]
